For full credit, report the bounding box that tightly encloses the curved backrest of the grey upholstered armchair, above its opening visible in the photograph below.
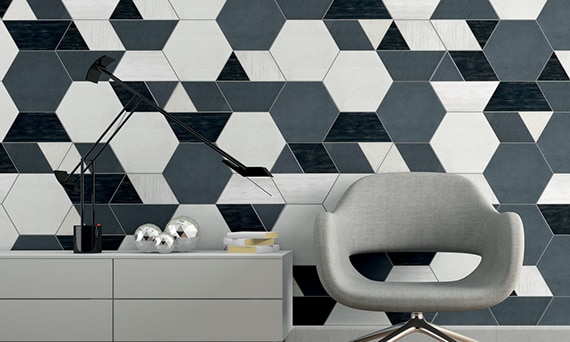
[326,173,497,254]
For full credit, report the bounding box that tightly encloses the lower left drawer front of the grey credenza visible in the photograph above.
[0,299,113,342]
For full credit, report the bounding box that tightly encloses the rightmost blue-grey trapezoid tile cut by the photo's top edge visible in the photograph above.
[431,0,499,19]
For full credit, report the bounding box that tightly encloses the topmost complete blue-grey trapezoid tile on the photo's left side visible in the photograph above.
[111,20,178,50]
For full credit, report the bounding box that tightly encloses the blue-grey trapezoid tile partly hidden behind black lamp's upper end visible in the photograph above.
[57,50,125,81]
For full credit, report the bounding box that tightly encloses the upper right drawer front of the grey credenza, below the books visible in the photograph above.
[114,258,283,299]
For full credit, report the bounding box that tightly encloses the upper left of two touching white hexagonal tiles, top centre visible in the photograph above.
[270,20,339,81]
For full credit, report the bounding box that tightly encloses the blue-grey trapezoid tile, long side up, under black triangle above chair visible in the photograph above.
[378,51,446,81]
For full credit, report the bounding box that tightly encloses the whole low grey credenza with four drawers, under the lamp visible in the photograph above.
[0,251,293,341]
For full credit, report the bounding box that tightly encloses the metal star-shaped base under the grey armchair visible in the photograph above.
[351,312,477,342]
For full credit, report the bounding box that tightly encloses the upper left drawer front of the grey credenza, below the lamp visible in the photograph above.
[0,259,113,299]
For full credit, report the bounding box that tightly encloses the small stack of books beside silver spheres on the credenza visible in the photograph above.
[224,231,279,253]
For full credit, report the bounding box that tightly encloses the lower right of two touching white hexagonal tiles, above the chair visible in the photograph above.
[324,51,392,112]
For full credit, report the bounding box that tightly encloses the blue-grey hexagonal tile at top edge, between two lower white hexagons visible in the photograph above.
[216,0,285,50]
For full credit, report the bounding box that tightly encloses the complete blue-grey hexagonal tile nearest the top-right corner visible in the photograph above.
[484,20,552,81]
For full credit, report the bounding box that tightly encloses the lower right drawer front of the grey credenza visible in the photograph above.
[114,300,288,342]
